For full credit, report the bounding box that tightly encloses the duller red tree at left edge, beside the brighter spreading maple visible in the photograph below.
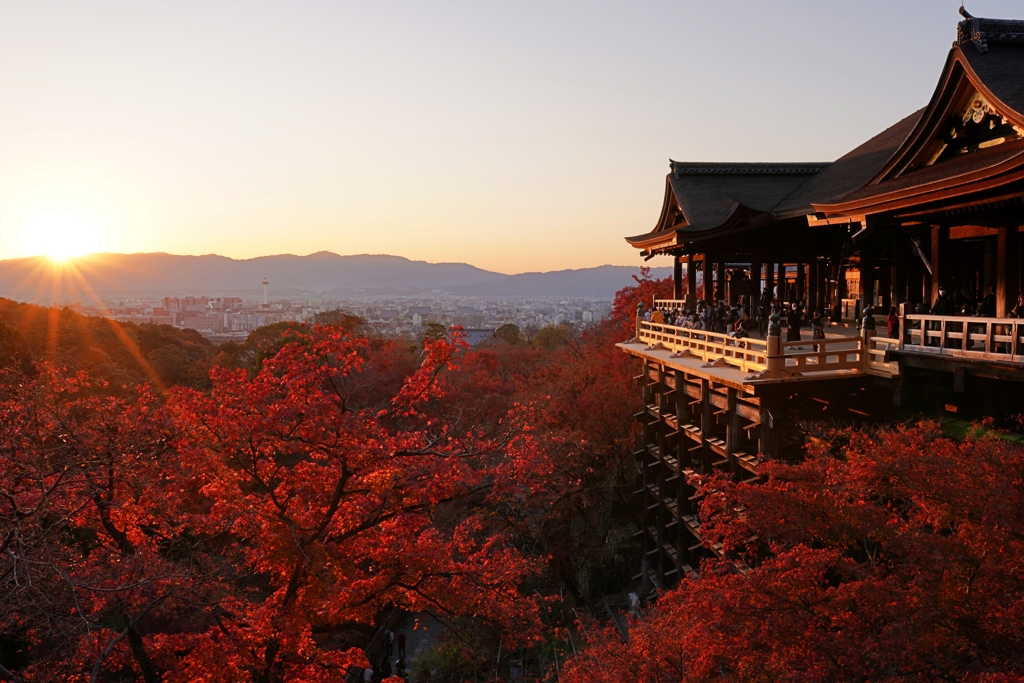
[0,365,186,683]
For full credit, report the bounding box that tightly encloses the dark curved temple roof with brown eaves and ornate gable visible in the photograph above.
[627,8,1024,251]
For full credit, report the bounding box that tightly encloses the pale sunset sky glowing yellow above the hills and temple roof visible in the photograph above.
[0,0,1024,273]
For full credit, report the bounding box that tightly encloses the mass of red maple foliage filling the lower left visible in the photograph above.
[0,328,537,682]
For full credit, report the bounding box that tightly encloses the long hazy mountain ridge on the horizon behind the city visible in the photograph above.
[0,252,671,301]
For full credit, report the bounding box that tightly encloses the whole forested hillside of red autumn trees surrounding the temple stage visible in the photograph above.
[0,278,1024,683]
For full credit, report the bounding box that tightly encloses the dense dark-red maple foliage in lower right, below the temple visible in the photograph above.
[562,424,1024,682]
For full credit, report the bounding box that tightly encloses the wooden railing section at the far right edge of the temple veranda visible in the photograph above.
[900,313,1024,362]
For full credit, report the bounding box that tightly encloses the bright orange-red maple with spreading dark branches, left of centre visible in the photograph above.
[154,327,535,682]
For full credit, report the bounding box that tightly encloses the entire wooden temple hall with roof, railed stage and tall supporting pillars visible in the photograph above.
[620,9,1024,585]
